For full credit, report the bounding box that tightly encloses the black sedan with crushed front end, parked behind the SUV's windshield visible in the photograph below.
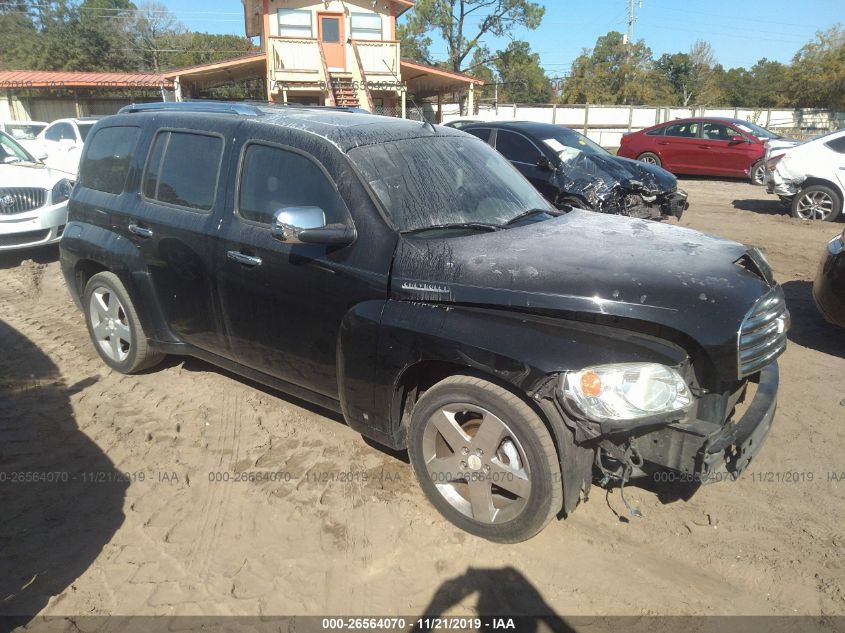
[460,121,689,220]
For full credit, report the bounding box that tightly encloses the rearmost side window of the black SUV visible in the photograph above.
[79,127,141,193]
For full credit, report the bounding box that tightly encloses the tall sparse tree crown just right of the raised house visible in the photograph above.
[400,0,546,72]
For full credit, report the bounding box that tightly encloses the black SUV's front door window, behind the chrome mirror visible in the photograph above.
[238,144,347,224]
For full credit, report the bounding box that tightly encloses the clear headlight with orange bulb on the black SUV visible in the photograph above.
[563,363,692,422]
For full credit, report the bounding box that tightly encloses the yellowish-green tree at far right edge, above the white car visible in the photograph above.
[786,24,845,108]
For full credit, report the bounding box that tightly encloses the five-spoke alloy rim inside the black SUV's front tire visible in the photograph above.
[422,403,532,524]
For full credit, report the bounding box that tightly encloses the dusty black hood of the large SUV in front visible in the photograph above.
[391,211,774,373]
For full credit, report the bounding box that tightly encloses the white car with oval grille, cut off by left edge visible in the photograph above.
[0,132,73,251]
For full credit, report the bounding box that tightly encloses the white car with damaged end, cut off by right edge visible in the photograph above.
[766,129,845,222]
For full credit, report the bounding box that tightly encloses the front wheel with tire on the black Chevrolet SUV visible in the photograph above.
[408,375,563,543]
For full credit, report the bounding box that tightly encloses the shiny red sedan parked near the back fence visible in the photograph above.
[617,117,780,185]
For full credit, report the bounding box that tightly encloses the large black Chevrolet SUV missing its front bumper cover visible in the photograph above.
[61,102,789,542]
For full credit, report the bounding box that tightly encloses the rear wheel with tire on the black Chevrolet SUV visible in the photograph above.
[83,272,164,374]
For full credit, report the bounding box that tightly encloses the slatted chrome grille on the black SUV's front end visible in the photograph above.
[739,286,789,378]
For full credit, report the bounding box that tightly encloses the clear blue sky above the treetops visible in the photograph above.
[164,0,845,77]
